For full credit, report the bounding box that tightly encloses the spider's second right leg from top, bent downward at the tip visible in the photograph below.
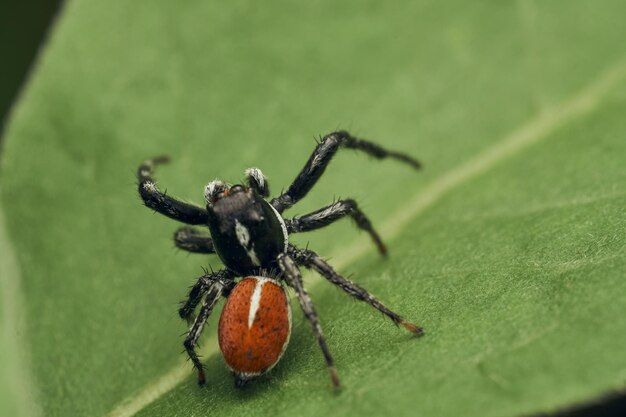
[285,199,387,255]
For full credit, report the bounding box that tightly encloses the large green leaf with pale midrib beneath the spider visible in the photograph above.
[0,0,626,416]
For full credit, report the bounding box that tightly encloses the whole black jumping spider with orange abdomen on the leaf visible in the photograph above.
[137,131,422,387]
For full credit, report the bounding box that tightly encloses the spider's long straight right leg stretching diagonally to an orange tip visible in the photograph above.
[288,245,424,336]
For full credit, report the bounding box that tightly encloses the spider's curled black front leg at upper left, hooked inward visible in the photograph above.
[137,156,208,224]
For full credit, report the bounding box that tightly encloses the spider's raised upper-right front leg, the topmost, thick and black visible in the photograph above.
[271,130,421,213]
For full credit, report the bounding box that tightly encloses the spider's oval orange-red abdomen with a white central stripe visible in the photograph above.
[218,277,291,382]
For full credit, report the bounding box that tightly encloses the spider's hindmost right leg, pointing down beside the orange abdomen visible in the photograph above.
[278,253,339,388]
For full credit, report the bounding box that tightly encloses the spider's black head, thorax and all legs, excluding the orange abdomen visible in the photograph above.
[137,131,422,386]
